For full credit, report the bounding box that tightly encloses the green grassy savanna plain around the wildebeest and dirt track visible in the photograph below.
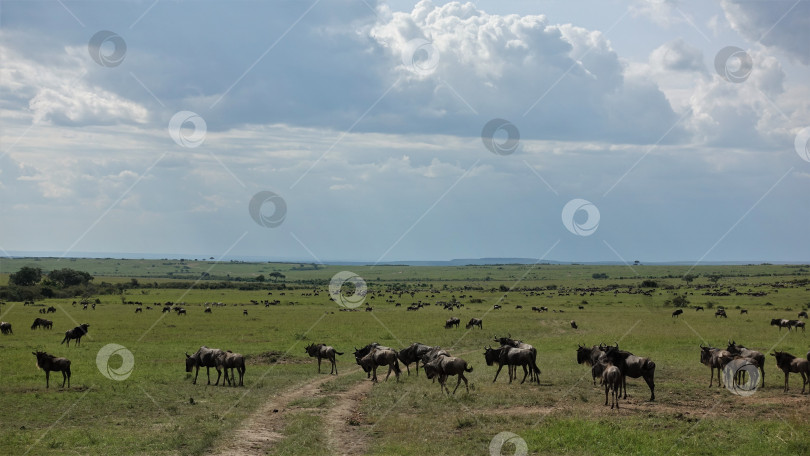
[0,260,810,455]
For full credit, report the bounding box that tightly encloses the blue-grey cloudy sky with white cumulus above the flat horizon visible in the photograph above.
[0,0,810,262]
